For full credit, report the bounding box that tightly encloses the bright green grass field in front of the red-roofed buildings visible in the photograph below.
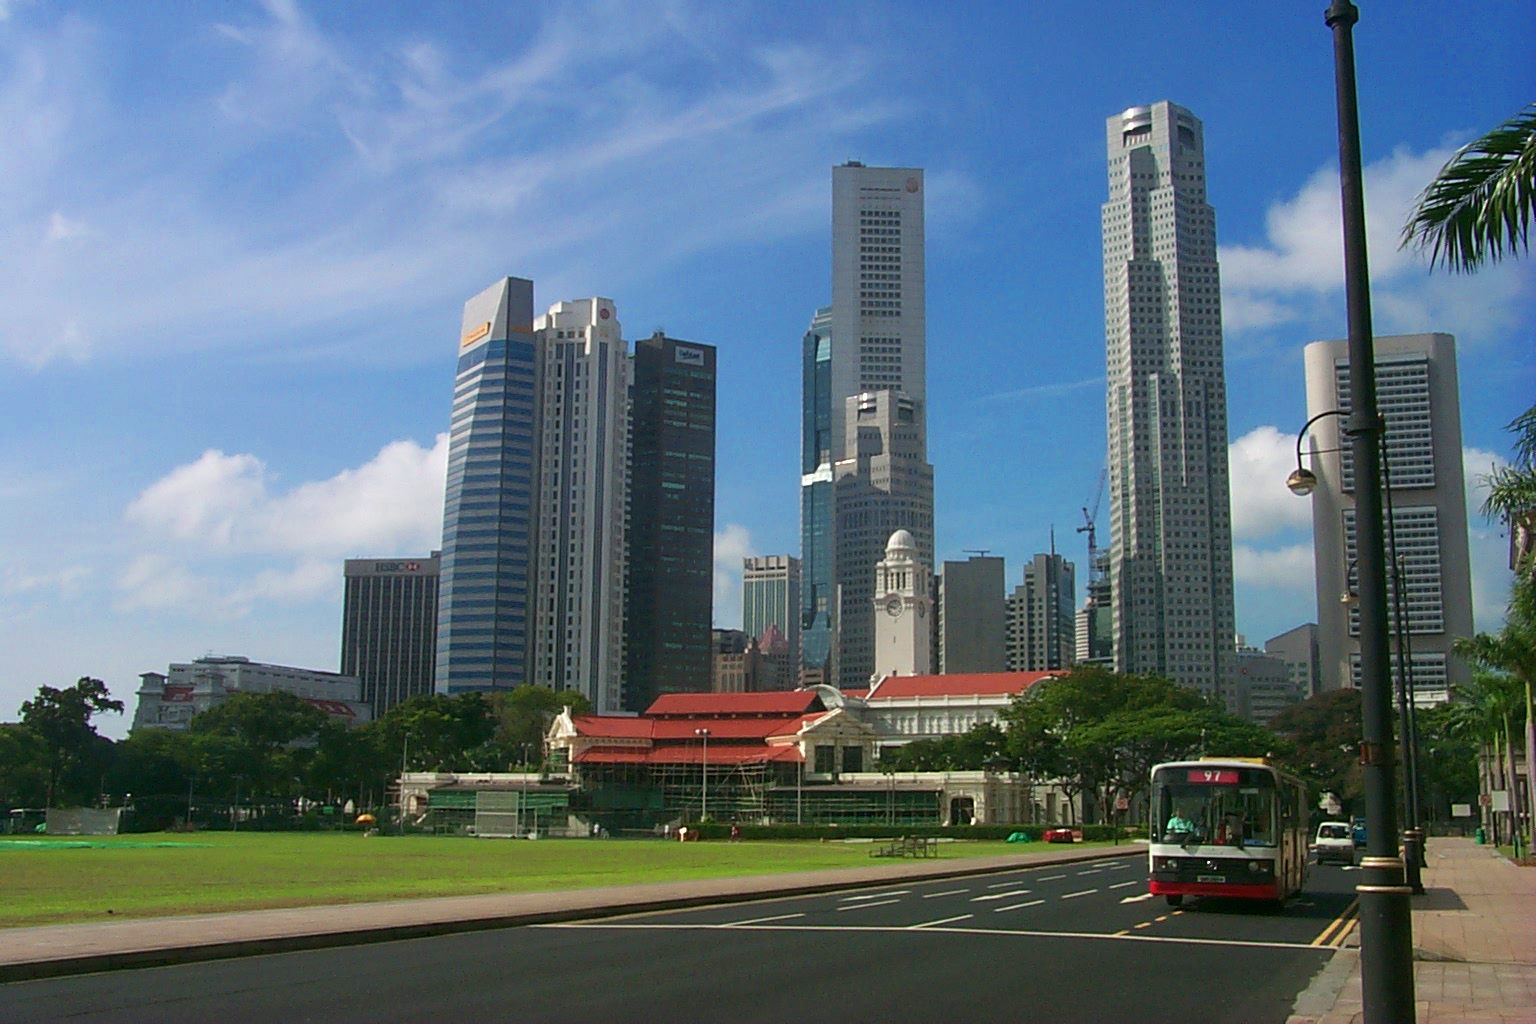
[0,832,1081,927]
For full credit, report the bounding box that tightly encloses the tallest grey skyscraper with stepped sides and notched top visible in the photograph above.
[1103,101,1236,699]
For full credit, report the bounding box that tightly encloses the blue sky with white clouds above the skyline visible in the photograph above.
[0,0,1536,735]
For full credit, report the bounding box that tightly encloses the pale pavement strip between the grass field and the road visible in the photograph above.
[0,844,1146,983]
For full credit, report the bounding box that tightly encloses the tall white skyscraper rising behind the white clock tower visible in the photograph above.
[823,161,934,686]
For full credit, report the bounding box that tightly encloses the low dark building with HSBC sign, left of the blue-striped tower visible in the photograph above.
[341,551,439,718]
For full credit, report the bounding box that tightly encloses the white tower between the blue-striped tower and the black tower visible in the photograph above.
[531,298,630,711]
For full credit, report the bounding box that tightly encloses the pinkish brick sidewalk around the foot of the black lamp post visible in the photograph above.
[1287,837,1536,1024]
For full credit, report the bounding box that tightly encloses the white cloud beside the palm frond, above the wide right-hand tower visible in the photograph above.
[1220,146,1528,341]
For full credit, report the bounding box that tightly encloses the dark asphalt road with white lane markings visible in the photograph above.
[0,857,1355,1024]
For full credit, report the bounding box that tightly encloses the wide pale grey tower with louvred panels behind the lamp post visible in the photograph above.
[1304,335,1473,702]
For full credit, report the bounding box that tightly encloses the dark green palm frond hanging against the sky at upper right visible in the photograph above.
[1402,103,1536,273]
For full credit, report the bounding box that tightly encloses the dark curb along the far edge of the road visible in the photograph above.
[0,849,1138,984]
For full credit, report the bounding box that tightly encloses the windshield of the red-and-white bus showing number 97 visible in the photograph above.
[1152,766,1279,846]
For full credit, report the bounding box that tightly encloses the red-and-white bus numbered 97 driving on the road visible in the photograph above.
[1147,757,1307,907]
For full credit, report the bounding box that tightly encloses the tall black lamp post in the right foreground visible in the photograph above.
[1324,0,1415,1024]
